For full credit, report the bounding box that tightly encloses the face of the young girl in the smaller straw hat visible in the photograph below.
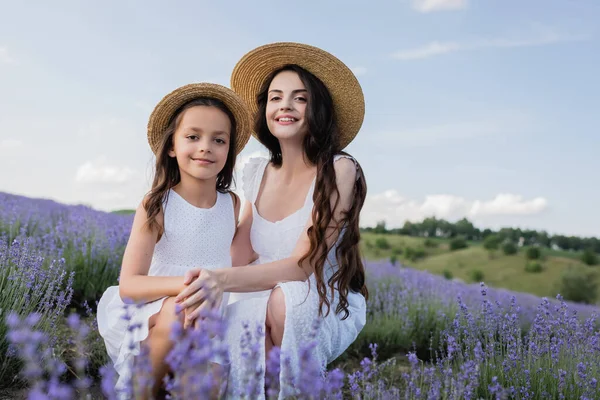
[169,106,231,180]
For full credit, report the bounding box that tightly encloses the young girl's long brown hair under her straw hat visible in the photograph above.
[144,97,237,238]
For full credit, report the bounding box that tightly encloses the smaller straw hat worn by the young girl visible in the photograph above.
[148,82,252,154]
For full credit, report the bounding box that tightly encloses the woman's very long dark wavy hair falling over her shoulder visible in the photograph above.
[254,65,368,319]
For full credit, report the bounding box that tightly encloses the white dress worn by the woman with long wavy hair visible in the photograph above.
[226,156,366,399]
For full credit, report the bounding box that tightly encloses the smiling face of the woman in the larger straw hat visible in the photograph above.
[266,71,308,141]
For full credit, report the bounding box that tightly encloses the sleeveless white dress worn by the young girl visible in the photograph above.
[97,190,236,388]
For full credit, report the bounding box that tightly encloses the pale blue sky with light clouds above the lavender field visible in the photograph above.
[0,0,600,236]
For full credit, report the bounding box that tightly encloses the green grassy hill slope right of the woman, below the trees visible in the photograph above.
[361,233,600,297]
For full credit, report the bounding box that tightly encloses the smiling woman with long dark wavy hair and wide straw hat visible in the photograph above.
[176,43,367,397]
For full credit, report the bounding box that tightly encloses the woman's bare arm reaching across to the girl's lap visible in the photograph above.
[176,158,357,307]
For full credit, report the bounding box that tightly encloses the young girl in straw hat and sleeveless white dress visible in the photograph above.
[97,83,251,395]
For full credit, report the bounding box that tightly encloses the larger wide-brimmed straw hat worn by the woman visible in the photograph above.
[231,42,365,150]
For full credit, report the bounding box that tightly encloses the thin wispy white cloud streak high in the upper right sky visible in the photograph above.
[392,30,589,61]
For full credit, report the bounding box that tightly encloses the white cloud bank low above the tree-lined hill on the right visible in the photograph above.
[361,190,548,227]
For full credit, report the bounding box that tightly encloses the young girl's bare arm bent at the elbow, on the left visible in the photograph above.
[119,203,185,303]
